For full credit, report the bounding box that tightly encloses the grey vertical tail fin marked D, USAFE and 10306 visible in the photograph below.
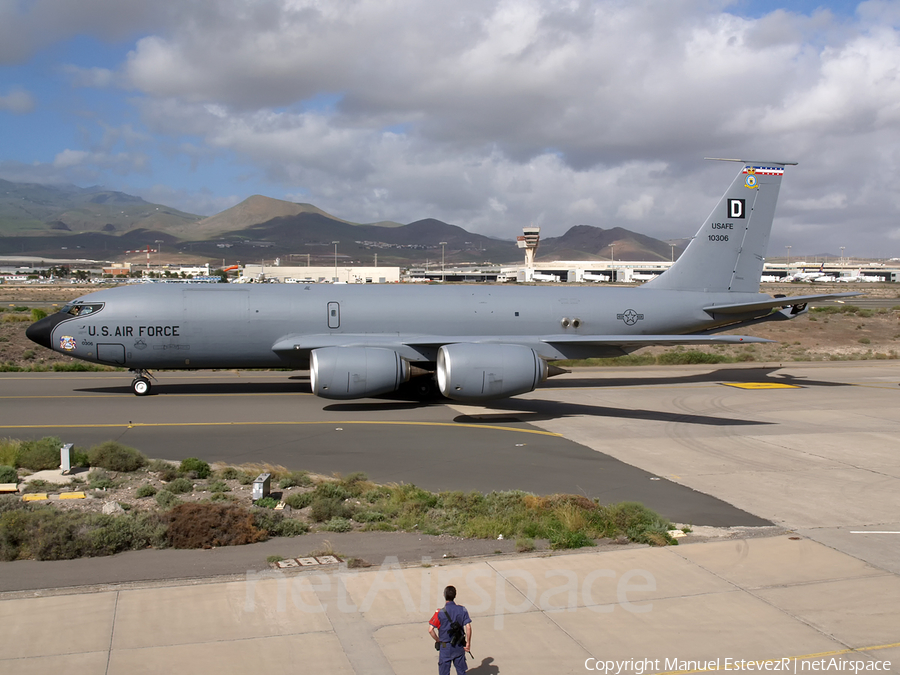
[643,159,796,293]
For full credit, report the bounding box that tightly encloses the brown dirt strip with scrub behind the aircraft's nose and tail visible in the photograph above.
[0,284,900,370]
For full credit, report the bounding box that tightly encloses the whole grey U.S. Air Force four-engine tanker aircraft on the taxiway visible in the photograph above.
[26,160,857,402]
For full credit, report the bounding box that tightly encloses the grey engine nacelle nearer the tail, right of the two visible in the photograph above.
[437,343,548,403]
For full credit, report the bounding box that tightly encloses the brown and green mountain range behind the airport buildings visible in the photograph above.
[0,180,686,266]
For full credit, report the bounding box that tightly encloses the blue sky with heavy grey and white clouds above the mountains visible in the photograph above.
[0,0,900,257]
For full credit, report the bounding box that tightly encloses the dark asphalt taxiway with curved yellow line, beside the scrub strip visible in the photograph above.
[0,372,769,526]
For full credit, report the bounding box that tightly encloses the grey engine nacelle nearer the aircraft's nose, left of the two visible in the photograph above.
[309,347,409,399]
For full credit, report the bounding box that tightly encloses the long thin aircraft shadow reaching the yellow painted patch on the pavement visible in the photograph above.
[539,366,852,390]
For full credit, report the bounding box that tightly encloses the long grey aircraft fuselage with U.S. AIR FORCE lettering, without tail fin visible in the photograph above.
[30,284,769,369]
